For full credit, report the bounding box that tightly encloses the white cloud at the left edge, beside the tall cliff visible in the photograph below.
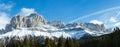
[0,12,9,29]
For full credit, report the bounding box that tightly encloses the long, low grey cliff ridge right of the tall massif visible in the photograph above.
[49,21,106,31]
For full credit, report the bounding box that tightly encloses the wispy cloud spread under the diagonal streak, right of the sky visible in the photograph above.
[70,6,120,28]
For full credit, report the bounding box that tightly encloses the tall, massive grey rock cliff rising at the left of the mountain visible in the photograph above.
[5,13,47,31]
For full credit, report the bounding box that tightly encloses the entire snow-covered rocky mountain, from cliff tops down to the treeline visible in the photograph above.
[0,13,112,38]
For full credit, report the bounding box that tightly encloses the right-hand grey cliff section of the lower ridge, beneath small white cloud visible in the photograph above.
[70,23,105,31]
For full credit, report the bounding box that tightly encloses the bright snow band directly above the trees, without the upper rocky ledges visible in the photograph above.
[0,28,111,39]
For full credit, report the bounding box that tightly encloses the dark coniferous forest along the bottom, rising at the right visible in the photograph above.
[0,28,120,47]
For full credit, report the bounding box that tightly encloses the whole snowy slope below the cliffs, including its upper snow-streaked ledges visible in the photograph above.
[0,25,111,39]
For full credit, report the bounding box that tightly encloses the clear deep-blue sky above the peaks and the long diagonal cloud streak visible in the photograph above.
[1,0,120,22]
